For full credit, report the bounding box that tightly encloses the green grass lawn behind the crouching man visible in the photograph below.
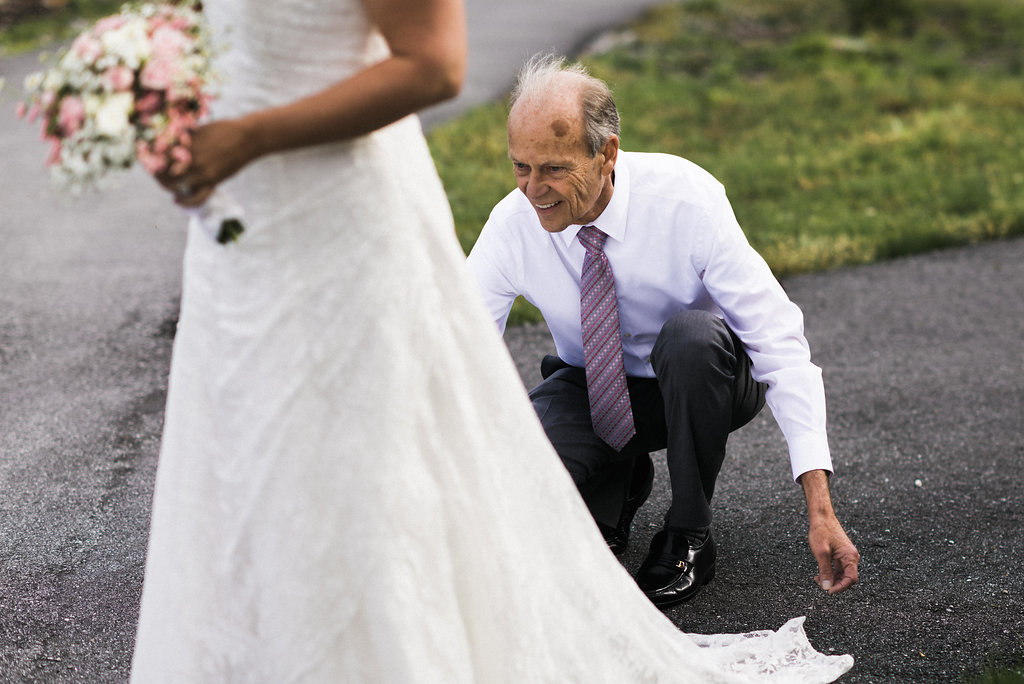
[429,0,1024,319]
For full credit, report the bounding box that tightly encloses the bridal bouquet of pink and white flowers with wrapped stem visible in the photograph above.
[17,4,243,244]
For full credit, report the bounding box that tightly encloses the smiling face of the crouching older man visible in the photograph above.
[509,101,618,232]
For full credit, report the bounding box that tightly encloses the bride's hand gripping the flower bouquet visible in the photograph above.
[157,119,256,207]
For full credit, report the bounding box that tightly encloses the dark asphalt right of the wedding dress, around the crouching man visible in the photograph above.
[509,233,1024,684]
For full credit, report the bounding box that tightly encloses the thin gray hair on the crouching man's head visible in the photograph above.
[509,54,618,157]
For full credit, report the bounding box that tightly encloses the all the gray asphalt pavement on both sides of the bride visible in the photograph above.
[0,0,1024,684]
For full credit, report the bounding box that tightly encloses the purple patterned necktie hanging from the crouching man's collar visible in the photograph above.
[577,225,636,452]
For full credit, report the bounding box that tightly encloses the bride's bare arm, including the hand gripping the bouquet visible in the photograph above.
[168,0,466,206]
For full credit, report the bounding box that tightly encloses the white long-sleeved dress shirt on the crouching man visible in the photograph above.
[468,152,833,479]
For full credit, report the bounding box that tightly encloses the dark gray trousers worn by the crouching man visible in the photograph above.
[529,311,765,529]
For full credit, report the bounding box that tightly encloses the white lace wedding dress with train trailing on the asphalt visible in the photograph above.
[132,0,852,684]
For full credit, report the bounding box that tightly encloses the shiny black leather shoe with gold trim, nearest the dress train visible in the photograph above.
[637,529,716,608]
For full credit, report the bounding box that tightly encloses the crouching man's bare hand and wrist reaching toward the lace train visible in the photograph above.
[800,470,860,594]
